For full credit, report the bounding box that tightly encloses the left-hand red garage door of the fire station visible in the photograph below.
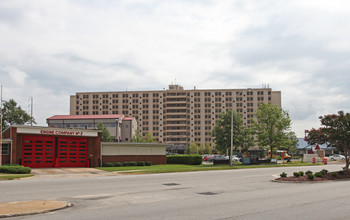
[22,136,55,167]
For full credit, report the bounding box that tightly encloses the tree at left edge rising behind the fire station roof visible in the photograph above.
[2,99,36,130]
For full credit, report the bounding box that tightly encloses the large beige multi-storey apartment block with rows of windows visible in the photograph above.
[70,85,281,145]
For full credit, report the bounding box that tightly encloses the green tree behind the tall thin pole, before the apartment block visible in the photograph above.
[211,110,249,153]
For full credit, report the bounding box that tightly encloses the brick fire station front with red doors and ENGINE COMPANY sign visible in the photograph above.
[2,126,101,168]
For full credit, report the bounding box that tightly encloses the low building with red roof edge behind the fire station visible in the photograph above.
[46,114,137,142]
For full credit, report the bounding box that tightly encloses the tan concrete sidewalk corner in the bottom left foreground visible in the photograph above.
[0,200,72,218]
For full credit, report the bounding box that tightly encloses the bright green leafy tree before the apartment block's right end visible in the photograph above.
[253,104,292,158]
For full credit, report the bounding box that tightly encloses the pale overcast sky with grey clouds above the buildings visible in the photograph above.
[0,0,350,137]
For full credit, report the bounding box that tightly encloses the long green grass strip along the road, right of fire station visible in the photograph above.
[97,162,321,173]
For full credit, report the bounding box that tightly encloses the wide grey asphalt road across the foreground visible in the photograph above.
[0,165,350,220]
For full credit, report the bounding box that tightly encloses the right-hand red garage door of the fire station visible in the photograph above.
[57,137,88,167]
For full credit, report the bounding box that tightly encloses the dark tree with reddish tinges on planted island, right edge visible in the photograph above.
[305,111,350,171]
